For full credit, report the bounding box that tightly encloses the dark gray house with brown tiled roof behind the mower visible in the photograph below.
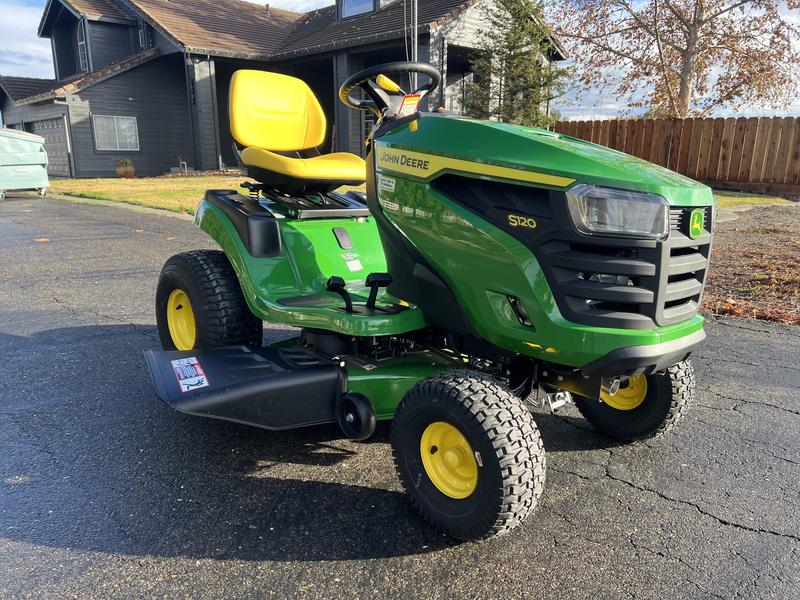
[0,0,564,177]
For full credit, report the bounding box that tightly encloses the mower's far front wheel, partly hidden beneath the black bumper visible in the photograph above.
[575,360,695,441]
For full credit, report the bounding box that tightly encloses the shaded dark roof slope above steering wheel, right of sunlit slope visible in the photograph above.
[280,0,477,55]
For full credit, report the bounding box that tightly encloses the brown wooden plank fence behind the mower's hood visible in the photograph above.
[555,117,800,196]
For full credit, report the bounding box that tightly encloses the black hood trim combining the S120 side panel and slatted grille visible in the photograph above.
[433,175,713,329]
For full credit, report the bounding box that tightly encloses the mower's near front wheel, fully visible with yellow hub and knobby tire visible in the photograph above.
[391,371,545,540]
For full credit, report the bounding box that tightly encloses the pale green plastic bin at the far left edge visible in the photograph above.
[0,129,48,200]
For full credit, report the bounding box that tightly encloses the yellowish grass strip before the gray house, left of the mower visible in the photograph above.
[50,175,247,215]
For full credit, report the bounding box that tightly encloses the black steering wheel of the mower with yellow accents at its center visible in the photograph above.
[339,61,442,118]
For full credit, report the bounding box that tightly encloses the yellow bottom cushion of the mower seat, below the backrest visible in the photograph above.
[242,148,367,183]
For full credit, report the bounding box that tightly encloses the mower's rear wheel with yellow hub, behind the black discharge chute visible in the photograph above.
[156,250,263,350]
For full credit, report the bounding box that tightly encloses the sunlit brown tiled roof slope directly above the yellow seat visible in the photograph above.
[127,0,304,59]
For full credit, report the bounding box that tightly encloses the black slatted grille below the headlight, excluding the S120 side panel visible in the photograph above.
[537,206,712,329]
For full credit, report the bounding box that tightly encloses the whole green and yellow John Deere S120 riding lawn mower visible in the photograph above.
[145,62,714,539]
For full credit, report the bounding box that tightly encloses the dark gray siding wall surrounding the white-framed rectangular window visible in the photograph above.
[69,55,194,177]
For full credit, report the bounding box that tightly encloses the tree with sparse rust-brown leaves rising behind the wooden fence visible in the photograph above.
[547,0,800,117]
